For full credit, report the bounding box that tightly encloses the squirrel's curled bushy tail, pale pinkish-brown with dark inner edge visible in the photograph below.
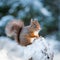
[5,20,24,43]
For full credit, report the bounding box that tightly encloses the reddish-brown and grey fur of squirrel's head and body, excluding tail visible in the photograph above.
[19,21,40,46]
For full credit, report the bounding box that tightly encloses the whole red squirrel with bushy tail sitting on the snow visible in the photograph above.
[5,19,41,46]
